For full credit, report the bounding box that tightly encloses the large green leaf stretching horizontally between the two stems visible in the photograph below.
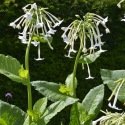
[31,81,78,101]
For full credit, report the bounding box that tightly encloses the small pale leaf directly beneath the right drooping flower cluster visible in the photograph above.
[79,51,101,64]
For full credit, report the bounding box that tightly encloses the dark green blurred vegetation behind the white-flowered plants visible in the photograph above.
[0,0,125,125]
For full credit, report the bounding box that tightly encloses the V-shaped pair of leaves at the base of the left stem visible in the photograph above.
[23,98,78,125]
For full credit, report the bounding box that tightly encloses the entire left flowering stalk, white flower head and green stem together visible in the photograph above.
[10,3,63,124]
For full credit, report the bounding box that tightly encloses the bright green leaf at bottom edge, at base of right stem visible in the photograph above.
[69,102,91,125]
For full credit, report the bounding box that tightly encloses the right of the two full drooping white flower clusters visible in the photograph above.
[62,13,110,79]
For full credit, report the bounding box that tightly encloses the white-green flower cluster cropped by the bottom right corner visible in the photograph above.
[92,111,125,125]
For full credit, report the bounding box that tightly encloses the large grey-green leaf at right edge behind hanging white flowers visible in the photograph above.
[101,69,125,103]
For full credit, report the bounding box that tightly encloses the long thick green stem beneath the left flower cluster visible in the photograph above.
[25,39,32,125]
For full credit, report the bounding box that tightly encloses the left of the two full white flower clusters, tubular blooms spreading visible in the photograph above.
[10,3,63,60]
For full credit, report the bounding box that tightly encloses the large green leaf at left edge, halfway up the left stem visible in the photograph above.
[0,54,22,82]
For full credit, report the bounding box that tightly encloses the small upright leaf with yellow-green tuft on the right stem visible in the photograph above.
[65,73,77,96]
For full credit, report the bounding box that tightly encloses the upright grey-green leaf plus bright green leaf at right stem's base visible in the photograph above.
[70,85,104,125]
